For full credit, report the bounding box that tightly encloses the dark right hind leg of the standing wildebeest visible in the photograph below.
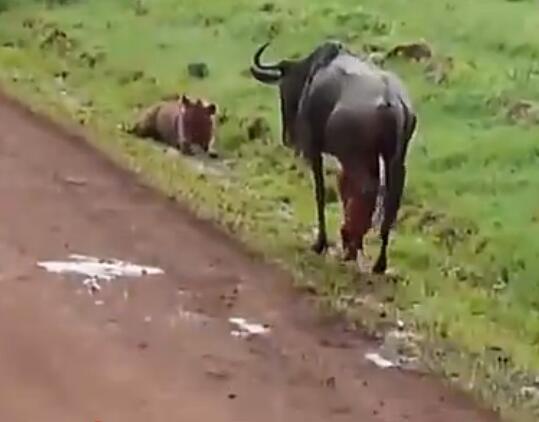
[373,160,406,274]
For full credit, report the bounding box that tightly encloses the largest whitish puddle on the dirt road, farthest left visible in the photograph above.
[37,254,164,293]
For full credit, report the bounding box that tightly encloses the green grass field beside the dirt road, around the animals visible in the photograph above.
[0,0,539,420]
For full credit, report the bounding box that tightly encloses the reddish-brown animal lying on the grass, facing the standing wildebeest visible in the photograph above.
[129,95,217,155]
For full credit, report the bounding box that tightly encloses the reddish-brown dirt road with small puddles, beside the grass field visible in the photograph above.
[0,93,498,422]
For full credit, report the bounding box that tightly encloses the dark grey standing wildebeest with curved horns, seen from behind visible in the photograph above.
[250,41,417,273]
